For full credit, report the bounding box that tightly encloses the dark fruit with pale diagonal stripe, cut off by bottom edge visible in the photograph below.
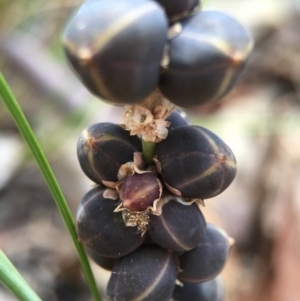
[106,245,176,301]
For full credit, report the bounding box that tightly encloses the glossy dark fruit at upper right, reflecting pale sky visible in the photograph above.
[159,11,252,108]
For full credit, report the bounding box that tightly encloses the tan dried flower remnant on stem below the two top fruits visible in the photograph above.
[122,91,175,143]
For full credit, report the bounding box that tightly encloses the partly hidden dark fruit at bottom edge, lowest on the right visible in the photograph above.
[173,276,224,301]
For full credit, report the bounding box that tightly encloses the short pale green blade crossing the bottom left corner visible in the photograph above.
[0,250,42,301]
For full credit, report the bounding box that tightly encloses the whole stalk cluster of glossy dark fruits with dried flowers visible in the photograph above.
[63,0,251,301]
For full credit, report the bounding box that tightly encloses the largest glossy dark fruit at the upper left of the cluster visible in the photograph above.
[63,0,168,104]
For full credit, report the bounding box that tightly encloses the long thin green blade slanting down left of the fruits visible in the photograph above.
[0,73,102,301]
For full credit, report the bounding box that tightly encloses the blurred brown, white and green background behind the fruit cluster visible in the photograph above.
[0,0,300,301]
